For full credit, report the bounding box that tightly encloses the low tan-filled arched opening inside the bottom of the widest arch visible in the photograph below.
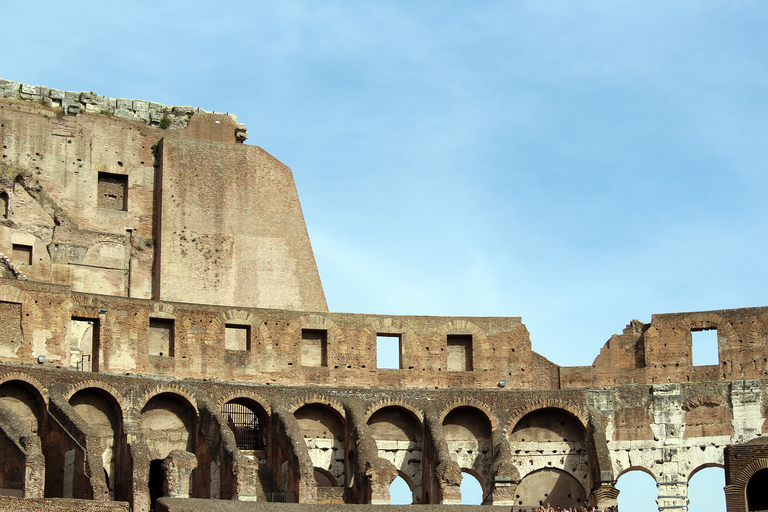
[515,468,584,512]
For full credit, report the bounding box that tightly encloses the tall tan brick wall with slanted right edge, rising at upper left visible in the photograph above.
[0,87,327,311]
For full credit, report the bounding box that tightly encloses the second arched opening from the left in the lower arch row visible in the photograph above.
[69,388,122,498]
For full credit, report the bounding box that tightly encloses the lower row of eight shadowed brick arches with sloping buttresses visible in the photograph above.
[0,378,589,510]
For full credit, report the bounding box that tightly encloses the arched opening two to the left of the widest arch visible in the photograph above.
[368,406,424,504]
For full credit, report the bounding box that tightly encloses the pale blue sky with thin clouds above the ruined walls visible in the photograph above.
[0,0,768,508]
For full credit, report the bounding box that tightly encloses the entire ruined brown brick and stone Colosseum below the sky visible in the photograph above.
[0,80,768,512]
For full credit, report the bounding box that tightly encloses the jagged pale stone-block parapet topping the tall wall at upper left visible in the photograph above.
[0,78,248,142]
